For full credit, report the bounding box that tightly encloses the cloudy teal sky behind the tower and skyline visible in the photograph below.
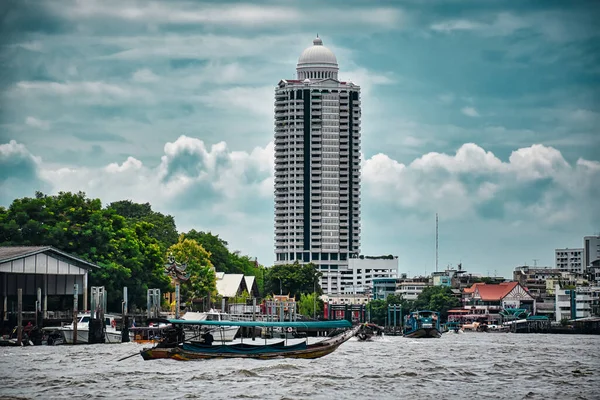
[0,0,600,278]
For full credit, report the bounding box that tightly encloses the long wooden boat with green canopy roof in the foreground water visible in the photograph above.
[140,320,360,361]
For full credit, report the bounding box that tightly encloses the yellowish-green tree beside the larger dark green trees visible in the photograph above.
[167,235,217,299]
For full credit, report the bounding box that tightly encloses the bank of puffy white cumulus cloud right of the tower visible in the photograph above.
[362,143,600,227]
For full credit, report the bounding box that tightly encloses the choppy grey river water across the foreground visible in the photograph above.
[0,333,600,400]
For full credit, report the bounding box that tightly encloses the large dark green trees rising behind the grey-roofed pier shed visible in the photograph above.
[0,192,169,311]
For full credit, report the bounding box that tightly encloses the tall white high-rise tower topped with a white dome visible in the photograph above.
[275,37,361,294]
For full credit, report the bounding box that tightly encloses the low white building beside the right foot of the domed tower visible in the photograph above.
[342,257,398,294]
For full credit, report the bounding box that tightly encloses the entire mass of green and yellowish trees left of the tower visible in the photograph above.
[0,192,264,311]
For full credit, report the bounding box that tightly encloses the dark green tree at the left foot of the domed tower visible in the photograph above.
[265,261,323,300]
